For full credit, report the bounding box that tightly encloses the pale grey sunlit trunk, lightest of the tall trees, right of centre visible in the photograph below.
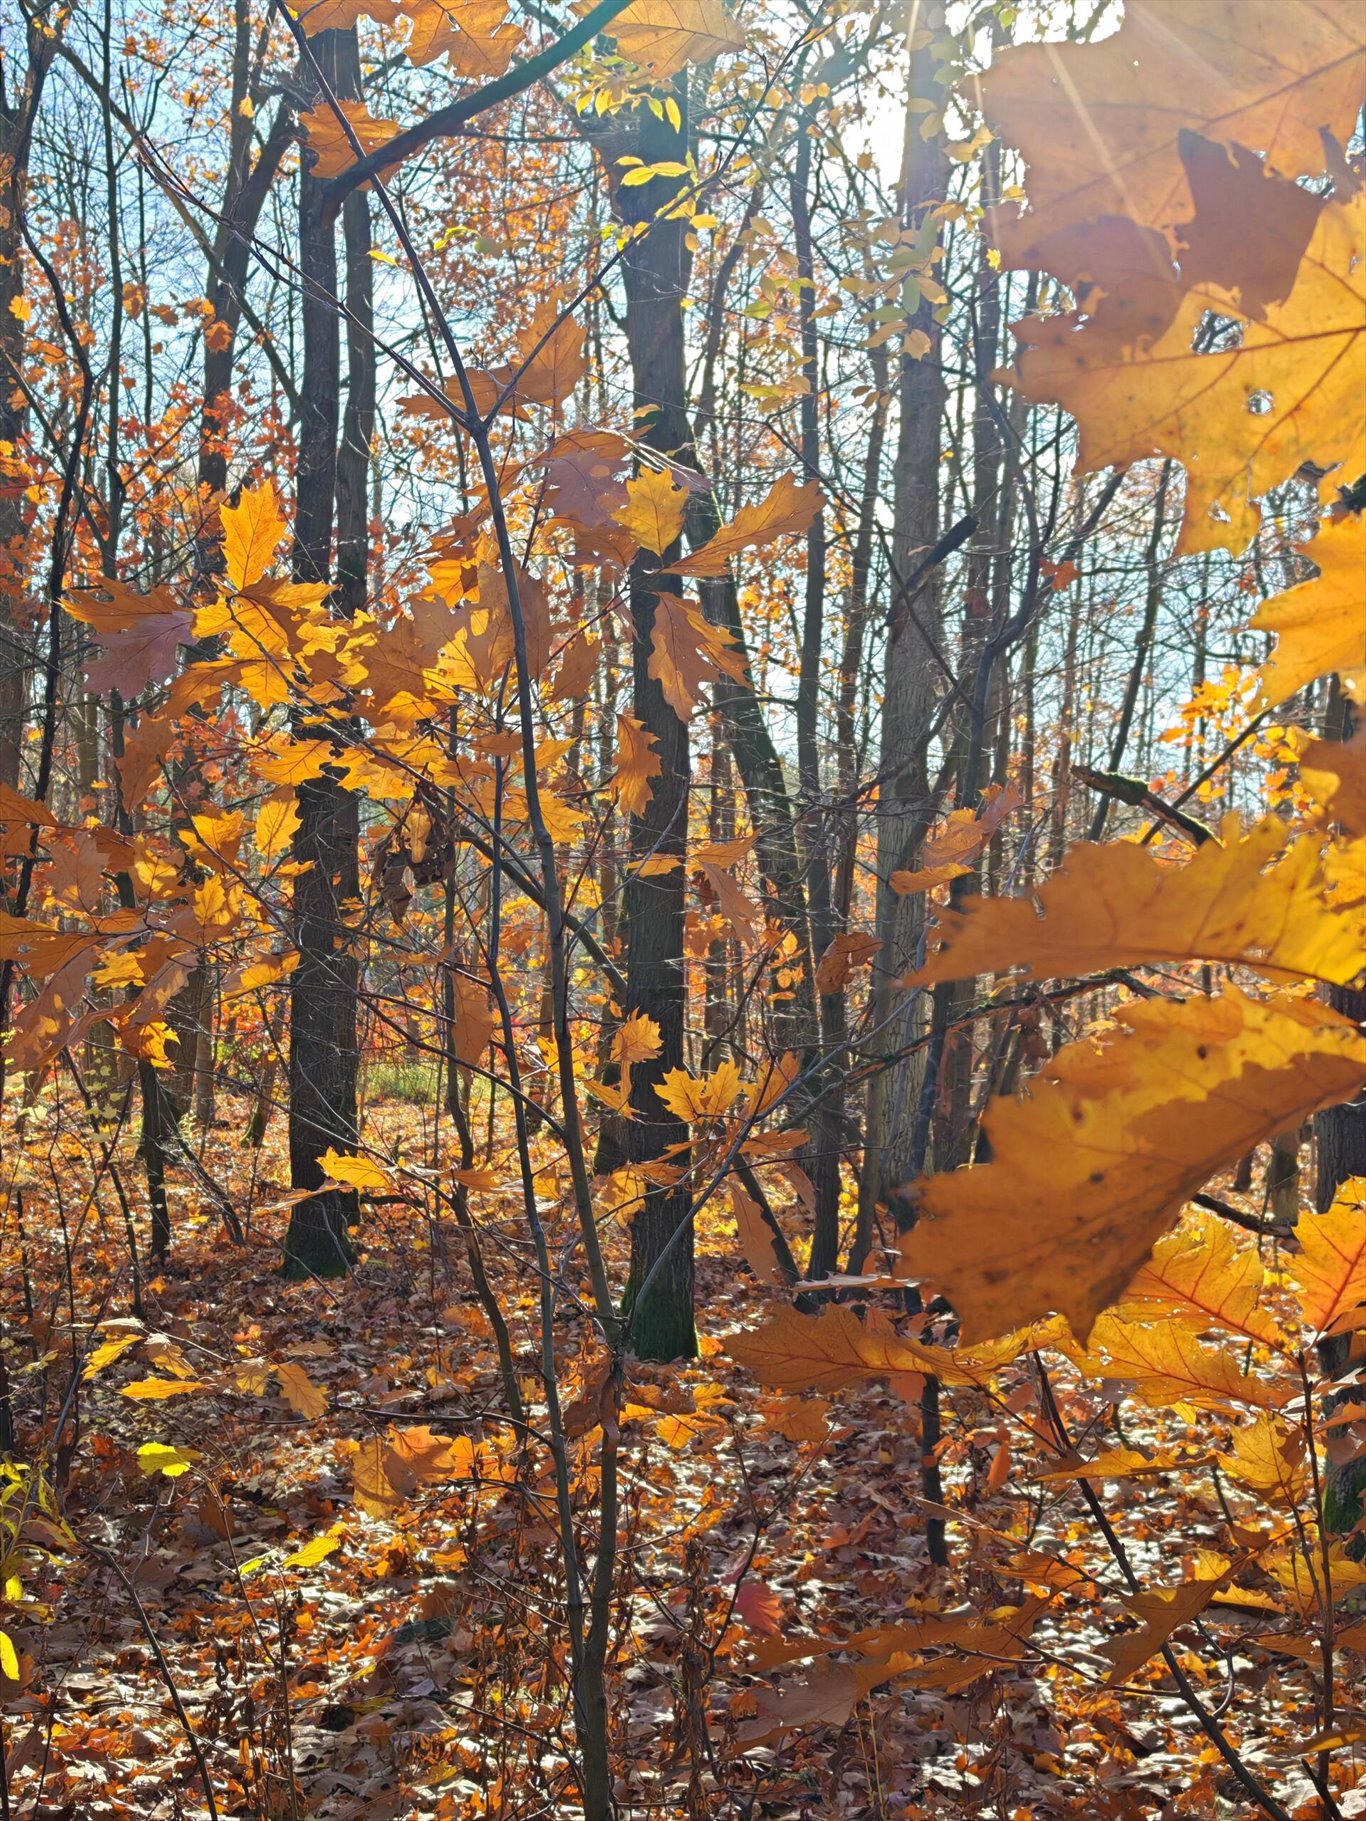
[860,0,949,1222]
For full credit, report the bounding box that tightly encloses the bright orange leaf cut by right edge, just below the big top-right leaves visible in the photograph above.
[1249,514,1366,705]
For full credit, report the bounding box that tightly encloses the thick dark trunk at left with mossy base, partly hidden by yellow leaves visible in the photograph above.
[284,27,364,1277]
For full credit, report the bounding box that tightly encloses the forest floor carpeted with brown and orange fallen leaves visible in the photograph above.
[0,1078,1366,1821]
